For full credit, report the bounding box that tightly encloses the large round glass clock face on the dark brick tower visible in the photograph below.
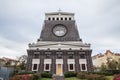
[53,25,67,36]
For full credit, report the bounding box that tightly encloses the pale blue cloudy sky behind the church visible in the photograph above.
[0,0,120,58]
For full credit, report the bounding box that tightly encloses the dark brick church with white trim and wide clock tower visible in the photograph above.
[27,12,93,75]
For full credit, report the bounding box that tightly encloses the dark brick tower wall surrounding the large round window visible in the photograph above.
[40,20,80,41]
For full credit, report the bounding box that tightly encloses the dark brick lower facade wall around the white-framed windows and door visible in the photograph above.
[27,50,93,74]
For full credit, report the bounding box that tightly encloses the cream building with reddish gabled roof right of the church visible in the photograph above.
[92,50,120,68]
